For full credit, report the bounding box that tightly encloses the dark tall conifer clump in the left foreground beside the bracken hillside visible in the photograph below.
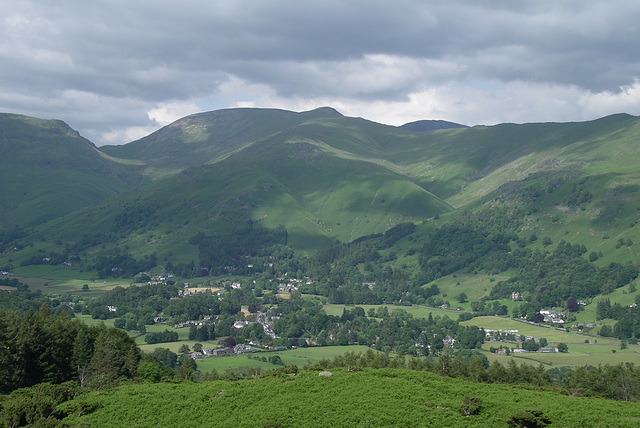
[0,307,140,392]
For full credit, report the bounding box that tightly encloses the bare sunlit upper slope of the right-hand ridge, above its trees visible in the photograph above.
[380,114,640,207]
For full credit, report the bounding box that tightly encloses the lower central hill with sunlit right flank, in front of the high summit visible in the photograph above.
[46,133,451,250]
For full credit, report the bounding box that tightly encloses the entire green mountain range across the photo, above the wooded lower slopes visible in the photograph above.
[3,108,640,270]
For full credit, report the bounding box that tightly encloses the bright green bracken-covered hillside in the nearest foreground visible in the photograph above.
[61,368,640,427]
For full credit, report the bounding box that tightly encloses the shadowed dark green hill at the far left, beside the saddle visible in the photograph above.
[0,114,144,229]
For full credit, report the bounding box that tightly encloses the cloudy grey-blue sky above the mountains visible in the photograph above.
[0,0,640,146]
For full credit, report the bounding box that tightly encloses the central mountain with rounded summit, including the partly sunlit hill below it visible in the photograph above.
[38,108,451,250]
